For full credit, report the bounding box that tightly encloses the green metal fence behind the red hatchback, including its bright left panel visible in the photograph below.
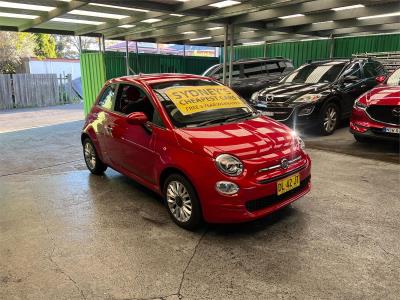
[81,51,219,115]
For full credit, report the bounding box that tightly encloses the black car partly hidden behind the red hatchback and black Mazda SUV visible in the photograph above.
[203,57,294,100]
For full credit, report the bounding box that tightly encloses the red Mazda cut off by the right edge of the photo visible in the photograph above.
[350,69,400,142]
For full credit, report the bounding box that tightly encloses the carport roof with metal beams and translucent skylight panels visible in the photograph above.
[0,0,400,46]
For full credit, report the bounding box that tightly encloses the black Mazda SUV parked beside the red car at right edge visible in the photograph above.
[250,59,386,135]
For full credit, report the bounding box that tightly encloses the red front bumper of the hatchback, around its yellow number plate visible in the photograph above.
[199,155,311,223]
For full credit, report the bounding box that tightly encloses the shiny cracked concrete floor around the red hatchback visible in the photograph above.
[0,108,400,299]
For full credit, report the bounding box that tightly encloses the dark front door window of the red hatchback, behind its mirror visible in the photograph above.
[115,84,164,127]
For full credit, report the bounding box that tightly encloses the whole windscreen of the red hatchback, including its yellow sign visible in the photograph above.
[151,79,255,127]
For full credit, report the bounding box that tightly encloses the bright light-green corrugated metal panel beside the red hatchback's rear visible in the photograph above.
[81,53,106,115]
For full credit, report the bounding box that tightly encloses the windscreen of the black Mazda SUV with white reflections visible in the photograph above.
[280,62,345,84]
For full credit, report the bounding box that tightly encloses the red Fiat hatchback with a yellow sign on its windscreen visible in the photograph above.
[81,74,311,229]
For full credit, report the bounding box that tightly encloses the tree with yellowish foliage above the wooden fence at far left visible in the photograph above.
[0,31,35,73]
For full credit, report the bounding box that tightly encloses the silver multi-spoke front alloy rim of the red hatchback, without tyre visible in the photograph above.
[167,181,192,223]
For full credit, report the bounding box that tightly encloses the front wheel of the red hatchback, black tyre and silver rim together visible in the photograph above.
[163,174,202,230]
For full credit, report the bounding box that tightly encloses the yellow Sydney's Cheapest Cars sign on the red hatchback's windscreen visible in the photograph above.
[165,85,246,115]
